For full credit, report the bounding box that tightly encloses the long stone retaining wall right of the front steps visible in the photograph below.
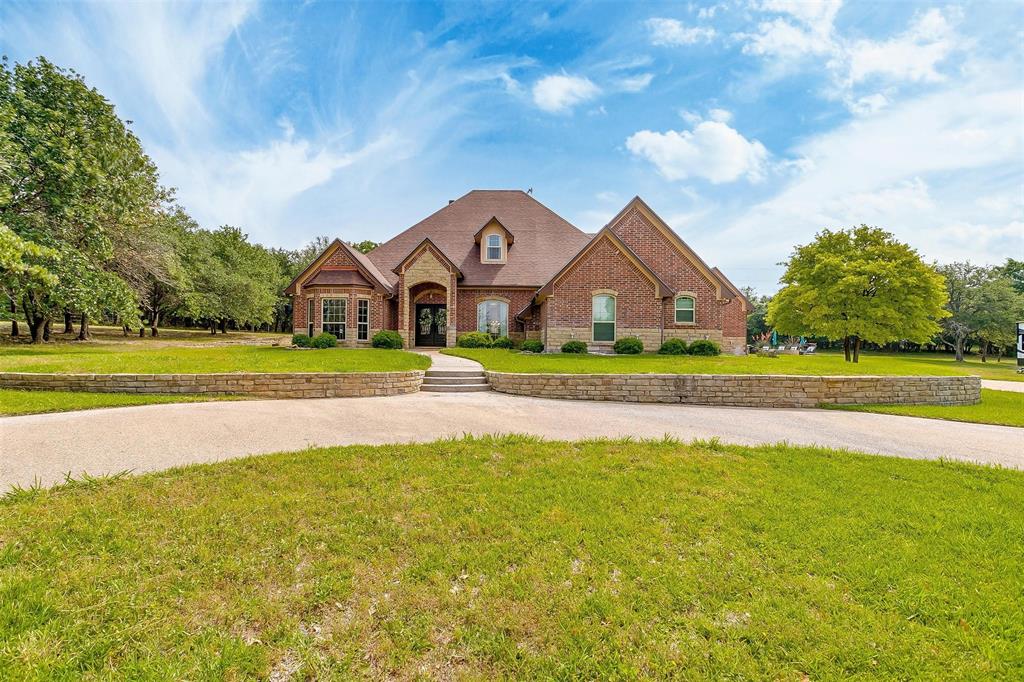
[487,372,981,408]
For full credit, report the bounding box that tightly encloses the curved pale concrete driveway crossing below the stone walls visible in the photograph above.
[0,392,1024,489]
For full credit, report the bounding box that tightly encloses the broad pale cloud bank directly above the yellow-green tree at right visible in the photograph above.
[720,79,1024,278]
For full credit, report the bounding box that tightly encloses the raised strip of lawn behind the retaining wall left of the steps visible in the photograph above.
[0,343,430,374]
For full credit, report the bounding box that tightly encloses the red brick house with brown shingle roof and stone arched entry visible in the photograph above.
[286,189,750,353]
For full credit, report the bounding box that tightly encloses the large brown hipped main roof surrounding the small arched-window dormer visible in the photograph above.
[367,189,590,287]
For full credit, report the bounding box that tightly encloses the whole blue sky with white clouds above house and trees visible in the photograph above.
[0,0,1024,292]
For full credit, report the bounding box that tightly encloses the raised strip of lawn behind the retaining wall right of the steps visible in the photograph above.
[441,348,1024,381]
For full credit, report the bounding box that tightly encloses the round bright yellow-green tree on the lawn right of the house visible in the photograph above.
[767,225,948,363]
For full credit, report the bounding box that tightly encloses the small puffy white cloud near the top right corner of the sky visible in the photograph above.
[843,9,956,84]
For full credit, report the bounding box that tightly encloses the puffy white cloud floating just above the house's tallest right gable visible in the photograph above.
[626,121,768,183]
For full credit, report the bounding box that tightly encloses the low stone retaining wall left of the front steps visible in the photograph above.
[0,370,423,398]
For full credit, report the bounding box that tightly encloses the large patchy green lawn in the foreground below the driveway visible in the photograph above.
[0,437,1024,680]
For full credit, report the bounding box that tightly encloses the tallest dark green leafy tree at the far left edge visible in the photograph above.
[0,57,164,342]
